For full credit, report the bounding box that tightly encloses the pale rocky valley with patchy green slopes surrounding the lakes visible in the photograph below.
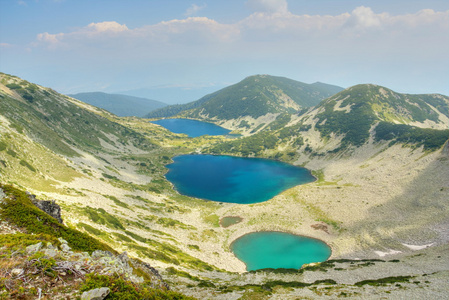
[0,73,449,299]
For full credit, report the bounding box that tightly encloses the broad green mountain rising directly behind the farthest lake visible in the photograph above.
[146,75,342,120]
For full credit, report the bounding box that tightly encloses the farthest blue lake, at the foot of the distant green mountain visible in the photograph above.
[151,119,231,137]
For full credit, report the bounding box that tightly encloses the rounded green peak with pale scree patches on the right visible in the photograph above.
[313,84,449,147]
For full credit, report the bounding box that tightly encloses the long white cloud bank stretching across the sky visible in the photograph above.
[36,6,449,67]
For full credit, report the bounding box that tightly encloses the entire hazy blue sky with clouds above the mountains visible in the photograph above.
[0,0,449,104]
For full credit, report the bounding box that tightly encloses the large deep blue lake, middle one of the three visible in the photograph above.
[166,155,315,204]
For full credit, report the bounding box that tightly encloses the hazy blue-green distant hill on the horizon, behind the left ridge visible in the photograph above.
[68,92,167,117]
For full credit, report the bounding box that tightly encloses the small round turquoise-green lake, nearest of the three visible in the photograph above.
[231,231,331,271]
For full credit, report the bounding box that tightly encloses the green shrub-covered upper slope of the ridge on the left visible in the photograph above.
[0,73,153,156]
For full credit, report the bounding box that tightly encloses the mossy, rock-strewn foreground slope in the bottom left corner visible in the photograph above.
[0,185,190,299]
